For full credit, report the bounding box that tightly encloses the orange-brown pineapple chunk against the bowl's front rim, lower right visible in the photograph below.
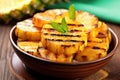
[76,47,107,62]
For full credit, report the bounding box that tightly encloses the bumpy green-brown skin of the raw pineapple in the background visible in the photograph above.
[0,0,64,24]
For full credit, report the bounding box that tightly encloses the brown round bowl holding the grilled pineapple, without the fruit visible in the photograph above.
[10,27,118,79]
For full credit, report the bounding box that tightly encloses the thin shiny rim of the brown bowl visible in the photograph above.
[9,25,118,66]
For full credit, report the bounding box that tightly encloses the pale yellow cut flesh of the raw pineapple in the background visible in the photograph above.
[0,0,32,14]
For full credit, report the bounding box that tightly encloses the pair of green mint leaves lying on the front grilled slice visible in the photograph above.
[51,18,68,33]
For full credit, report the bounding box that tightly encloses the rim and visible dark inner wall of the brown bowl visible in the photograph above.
[10,26,118,65]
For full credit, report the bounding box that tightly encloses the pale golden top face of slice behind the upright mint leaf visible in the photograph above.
[54,11,98,30]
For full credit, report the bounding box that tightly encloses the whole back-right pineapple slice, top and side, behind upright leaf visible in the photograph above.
[58,11,100,38]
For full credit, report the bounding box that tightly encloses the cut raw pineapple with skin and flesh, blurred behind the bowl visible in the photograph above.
[0,0,68,23]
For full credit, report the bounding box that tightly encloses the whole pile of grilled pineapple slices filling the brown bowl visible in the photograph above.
[15,9,111,62]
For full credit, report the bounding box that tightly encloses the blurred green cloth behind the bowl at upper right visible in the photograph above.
[48,0,120,24]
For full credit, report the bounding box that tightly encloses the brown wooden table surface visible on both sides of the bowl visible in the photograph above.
[0,23,120,80]
